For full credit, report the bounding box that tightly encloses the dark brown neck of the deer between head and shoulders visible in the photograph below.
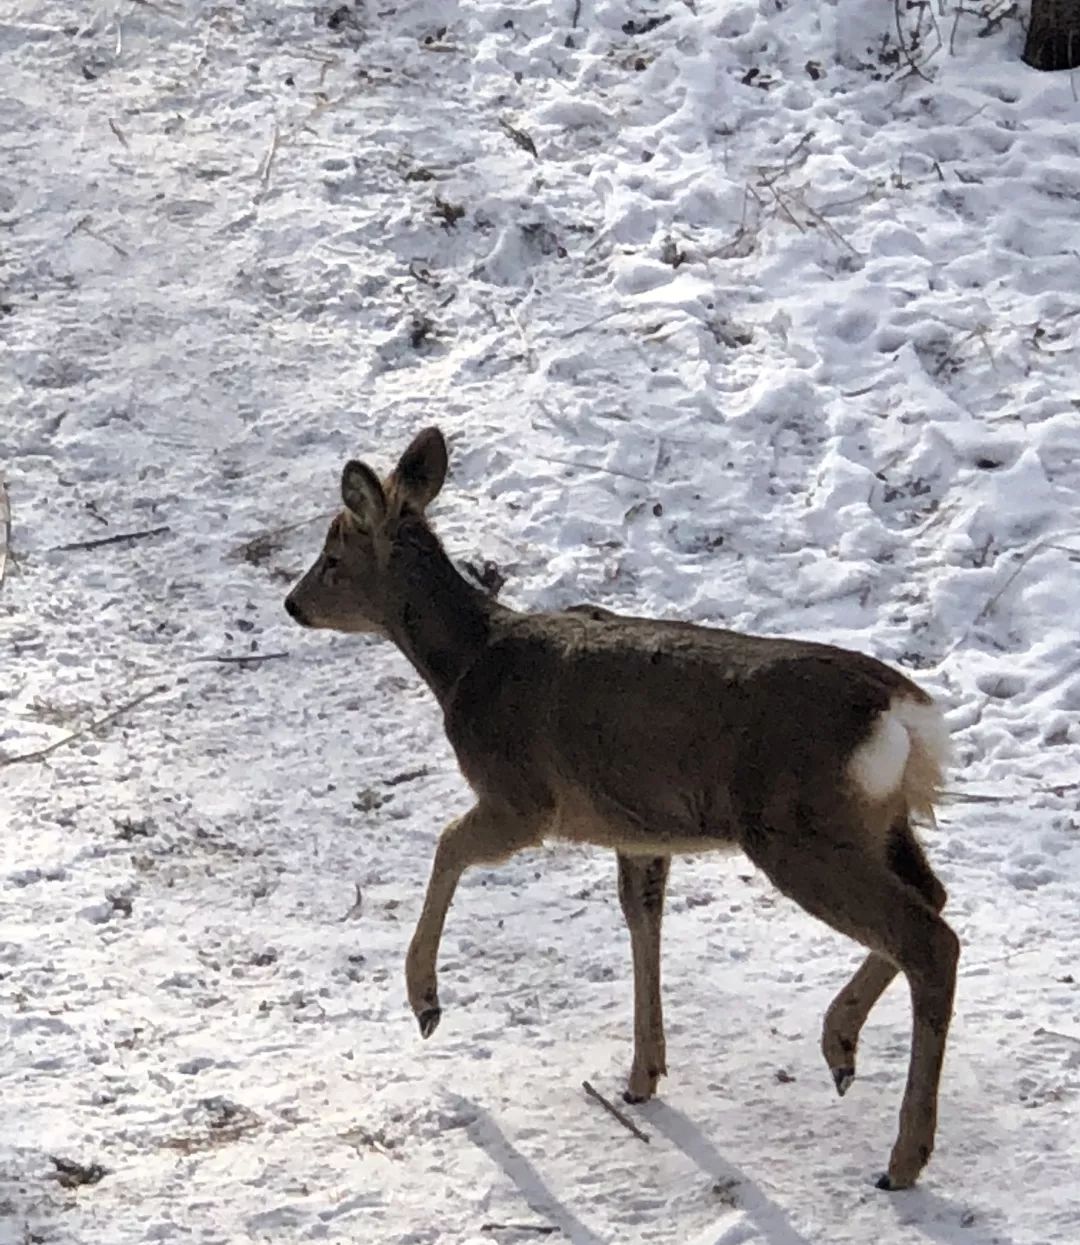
[386,522,504,706]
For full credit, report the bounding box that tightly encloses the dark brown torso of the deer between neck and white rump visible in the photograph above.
[445,609,926,854]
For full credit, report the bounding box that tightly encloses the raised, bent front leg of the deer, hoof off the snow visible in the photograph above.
[405,803,542,1037]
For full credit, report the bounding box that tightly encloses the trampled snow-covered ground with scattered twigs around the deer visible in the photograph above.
[0,0,1080,1245]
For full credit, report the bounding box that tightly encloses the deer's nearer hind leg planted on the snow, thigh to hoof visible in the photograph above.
[745,814,959,1189]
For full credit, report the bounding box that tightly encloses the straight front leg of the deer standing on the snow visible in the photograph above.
[618,853,671,1102]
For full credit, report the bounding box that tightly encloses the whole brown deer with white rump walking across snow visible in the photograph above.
[285,428,959,1189]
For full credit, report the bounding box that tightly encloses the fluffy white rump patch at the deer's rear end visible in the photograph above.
[847,700,949,801]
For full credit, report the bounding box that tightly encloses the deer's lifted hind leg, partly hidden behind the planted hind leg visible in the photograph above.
[821,817,947,1097]
